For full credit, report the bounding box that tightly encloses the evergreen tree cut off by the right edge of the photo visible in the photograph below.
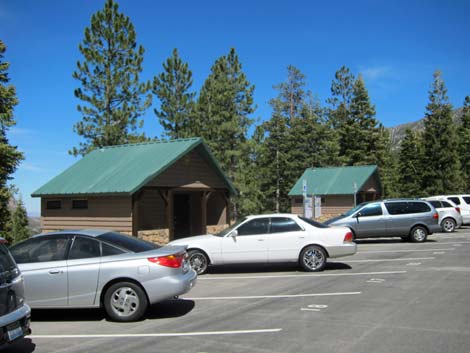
[458,96,470,193]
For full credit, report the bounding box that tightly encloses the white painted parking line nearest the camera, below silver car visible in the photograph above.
[28,328,282,339]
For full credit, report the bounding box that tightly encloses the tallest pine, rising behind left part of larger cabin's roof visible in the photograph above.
[70,0,152,156]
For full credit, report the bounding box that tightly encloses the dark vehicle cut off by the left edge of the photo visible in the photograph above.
[0,238,31,345]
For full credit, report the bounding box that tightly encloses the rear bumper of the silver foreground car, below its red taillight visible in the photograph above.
[142,269,197,304]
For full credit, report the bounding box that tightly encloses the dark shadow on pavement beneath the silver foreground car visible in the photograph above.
[31,299,195,320]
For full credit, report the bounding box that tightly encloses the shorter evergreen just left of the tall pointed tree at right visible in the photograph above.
[398,129,426,197]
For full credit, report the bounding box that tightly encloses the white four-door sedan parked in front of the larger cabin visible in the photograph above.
[169,214,356,274]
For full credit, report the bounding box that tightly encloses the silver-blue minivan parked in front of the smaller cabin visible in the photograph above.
[325,199,441,242]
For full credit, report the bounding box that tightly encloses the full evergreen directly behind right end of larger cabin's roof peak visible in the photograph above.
[192,48,256,217]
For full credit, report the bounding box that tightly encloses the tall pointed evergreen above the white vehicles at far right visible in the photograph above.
[423,71,462,195]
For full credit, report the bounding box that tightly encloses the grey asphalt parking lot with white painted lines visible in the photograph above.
[4,227,470,353]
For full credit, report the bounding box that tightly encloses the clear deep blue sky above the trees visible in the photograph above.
[0,0,470,215]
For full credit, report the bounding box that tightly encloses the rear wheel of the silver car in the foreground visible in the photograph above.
[104,282,148,322]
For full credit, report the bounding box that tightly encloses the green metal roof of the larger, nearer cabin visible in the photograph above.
[31,138,236,197]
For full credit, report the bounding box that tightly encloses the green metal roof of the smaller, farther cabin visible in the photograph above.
[289,165,377,196]
